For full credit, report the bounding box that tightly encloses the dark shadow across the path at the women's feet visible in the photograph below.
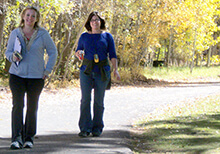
[0,130,132,154]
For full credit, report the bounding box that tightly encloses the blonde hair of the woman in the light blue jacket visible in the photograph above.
[19,6,40,28]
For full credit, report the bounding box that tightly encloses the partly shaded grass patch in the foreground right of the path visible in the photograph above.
[131,88,220,154]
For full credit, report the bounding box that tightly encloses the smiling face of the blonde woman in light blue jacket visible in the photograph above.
[23,9,37,27]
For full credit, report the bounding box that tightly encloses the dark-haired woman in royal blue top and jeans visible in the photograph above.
[75,12,120,137]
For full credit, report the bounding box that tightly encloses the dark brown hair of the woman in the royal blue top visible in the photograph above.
[85,11,106,31]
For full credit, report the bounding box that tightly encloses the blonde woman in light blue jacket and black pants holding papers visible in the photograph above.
[5,6,57,149]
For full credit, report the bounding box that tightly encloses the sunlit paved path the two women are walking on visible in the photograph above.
[0,82,220,154]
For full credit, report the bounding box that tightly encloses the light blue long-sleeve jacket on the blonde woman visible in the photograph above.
[5,28,57,79]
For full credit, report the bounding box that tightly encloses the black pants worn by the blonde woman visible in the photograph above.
[9,74,44,145]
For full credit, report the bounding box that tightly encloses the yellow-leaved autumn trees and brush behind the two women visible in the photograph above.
[0,0,219,80]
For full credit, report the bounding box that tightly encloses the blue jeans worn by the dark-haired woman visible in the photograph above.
[79,70,110,134]
